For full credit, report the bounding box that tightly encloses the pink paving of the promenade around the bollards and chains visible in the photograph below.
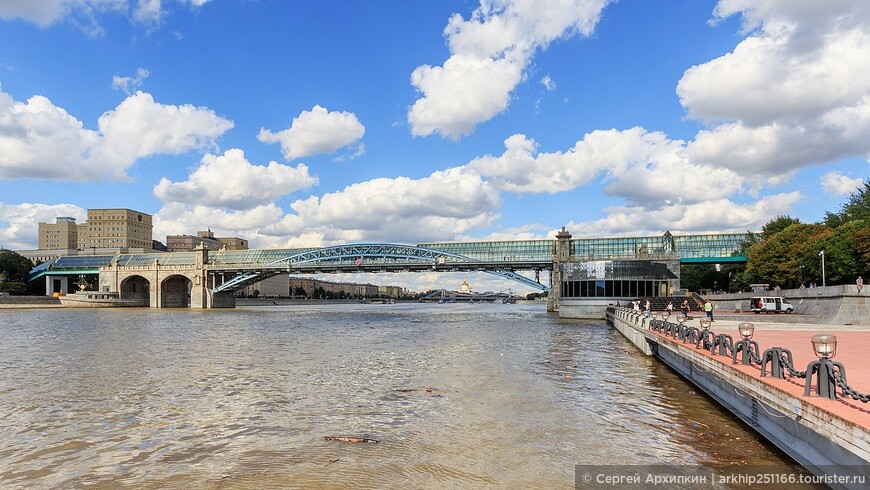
[651,322,870,428]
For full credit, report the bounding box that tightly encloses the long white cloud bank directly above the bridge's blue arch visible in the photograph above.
[154,167,501,247]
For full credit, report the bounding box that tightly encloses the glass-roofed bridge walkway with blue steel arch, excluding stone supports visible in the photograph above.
[29,232,747,294]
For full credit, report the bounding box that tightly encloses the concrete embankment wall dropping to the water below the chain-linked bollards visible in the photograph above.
[607,308,870,488]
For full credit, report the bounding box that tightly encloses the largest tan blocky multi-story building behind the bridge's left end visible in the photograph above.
[78,208,153,250]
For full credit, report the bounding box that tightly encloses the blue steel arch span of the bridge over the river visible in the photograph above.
[209,243,553,293]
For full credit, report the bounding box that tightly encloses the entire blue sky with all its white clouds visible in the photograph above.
[0,0,870,289]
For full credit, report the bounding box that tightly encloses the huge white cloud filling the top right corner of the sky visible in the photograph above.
[677,0,870,176]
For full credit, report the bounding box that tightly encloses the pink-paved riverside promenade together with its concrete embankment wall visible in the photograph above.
[607,309,870,488]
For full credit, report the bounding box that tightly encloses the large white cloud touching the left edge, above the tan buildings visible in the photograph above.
[0,86,233,181]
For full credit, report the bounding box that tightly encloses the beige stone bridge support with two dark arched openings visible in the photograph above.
[100,248,236,308]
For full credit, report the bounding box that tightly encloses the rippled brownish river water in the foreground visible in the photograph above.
[0,302,804,488]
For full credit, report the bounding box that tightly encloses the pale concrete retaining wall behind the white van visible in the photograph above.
[705,285,870,326]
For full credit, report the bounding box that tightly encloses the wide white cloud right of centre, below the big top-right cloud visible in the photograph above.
[468,127,743,207]
